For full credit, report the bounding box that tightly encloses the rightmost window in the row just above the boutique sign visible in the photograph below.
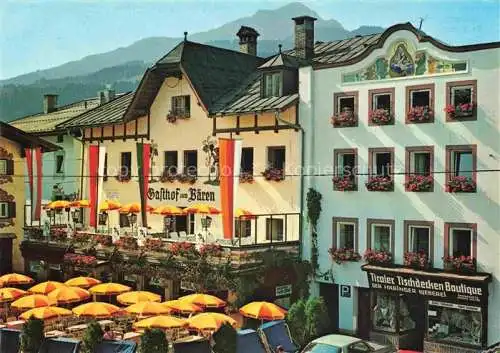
[444,223,477,258]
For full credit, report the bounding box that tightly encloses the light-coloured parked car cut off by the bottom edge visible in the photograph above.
[301,335,397,353]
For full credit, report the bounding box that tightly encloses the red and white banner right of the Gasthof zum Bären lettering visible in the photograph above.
[219,138,242,239]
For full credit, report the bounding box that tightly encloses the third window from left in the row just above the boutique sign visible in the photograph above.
[404,221,434,262]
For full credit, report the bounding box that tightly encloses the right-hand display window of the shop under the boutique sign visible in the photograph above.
[427,300,484,346]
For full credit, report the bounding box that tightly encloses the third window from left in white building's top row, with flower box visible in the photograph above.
[406,84,434,123]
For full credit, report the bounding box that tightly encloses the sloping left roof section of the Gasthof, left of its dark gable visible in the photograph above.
[57,92,134,129]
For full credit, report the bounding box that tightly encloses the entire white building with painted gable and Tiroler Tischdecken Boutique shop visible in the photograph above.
[298,18,500,352]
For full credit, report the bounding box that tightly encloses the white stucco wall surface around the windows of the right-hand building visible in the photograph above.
[299,31,500,343]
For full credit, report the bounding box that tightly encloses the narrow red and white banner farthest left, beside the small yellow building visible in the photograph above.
[24,147,43,221]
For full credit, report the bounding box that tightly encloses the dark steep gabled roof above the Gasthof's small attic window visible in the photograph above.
[125,40,264,120]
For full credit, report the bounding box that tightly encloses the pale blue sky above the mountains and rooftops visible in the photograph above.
[0,0,500,79]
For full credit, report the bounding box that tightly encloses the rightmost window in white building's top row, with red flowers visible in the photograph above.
[446,80,477,121]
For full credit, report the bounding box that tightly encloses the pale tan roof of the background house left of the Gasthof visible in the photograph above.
[10,97,100,134]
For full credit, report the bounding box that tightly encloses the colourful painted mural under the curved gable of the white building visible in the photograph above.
[342,41,467,83]
